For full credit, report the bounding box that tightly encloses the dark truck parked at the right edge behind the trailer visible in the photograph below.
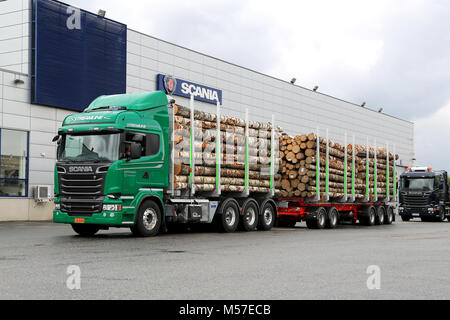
[399,167,450,221]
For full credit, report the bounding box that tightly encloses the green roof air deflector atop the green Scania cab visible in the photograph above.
[84,91,169,111]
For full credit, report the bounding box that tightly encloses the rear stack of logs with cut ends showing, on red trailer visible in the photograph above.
[280,133,398,200]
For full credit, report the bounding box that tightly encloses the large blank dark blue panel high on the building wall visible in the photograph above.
[31,0,127,111]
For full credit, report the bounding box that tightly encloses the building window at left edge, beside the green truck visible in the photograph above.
[0,129,28,197]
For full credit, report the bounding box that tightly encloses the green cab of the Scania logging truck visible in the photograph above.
[53,91,170,235]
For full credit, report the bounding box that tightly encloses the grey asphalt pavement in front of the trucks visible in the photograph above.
[0,219,450,300]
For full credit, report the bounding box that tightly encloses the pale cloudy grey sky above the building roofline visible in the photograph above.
[66,0,450,170]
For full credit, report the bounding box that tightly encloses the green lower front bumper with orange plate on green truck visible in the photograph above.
[53,210,134,227]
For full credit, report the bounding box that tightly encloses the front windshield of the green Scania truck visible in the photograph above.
[58,133,120,162]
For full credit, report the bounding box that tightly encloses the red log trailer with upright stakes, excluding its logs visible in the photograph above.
[278,129,397,229]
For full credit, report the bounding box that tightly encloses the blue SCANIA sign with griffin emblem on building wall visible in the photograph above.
[156,74,222,104]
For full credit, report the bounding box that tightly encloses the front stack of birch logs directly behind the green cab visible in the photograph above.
[173,105,281,194]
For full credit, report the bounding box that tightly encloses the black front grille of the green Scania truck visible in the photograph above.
[57,164,108,216]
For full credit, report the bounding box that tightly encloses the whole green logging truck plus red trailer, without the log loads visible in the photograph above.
[53,91,395,236]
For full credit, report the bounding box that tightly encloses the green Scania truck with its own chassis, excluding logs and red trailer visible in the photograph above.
[53,91,277,236]
